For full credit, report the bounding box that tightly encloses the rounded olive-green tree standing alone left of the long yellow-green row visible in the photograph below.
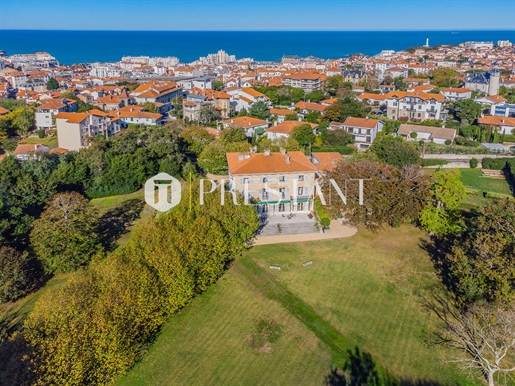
[30,192,103,274]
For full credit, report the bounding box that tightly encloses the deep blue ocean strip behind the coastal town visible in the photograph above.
[0,30,515,65]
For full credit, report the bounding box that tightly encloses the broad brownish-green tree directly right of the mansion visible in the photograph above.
[322,160,429,231]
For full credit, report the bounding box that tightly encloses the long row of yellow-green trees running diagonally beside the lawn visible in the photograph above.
[23,187,258,385]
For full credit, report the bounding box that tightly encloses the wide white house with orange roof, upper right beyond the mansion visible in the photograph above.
[385,91,445,121]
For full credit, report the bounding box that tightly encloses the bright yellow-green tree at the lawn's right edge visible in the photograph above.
[419,169,467,235]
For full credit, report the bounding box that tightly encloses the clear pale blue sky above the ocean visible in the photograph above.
[0,0,515,31]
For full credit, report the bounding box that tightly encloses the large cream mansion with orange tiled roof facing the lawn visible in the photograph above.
[227,150,317,215]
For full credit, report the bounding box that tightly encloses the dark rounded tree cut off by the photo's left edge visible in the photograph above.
[0,247,29,304]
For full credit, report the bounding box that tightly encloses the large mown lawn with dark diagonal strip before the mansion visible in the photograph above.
[118,226,480,385]
